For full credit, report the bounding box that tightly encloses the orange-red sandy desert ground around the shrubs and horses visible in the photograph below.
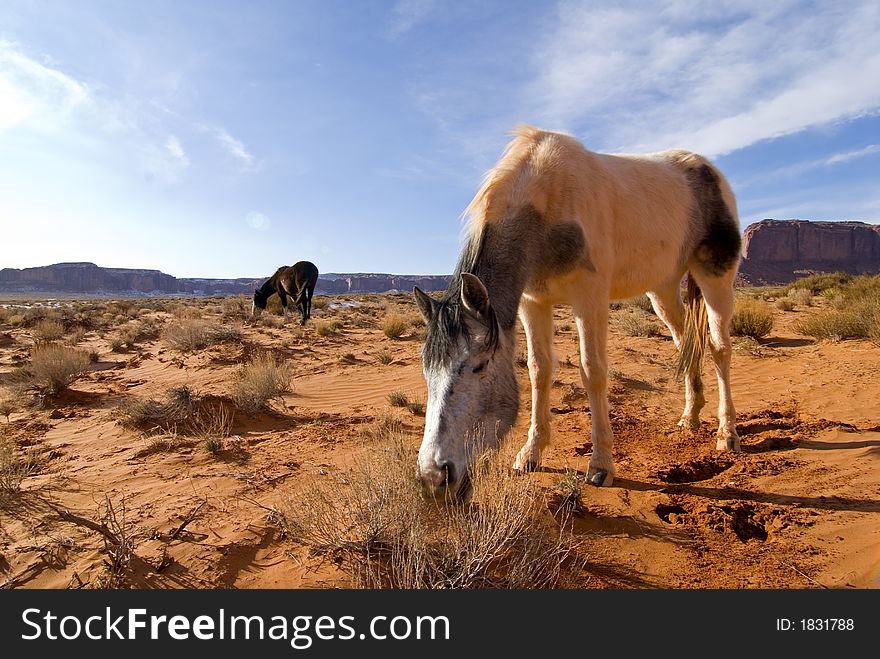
[0,296,880,589]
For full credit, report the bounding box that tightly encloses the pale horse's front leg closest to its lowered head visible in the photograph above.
[513,297,553,471]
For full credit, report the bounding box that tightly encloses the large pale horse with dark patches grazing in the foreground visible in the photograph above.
[413,126,741,497]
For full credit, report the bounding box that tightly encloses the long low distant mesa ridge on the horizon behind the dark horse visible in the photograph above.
[0,263,450,296]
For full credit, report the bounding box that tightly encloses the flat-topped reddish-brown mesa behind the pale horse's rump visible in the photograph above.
[739,220,880,285]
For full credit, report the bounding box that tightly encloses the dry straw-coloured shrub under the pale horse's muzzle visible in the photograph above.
[275,434,585,589]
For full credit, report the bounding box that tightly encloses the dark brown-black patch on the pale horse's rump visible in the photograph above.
[687,164,742,277]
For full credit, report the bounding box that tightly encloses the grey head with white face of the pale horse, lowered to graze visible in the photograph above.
[413,274,519,497]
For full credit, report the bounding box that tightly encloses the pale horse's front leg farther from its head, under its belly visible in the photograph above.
[572,303,616,486]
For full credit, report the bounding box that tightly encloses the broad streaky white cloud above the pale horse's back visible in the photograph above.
[525,0,880,156]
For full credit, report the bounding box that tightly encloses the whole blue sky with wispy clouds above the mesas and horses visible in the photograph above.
[0,0,880,277]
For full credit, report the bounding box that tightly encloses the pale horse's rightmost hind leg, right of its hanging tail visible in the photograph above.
[691,268,740,451]
